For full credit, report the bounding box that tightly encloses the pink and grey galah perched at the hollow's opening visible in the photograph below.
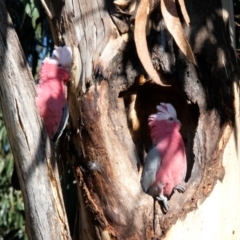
[141,103,187,212]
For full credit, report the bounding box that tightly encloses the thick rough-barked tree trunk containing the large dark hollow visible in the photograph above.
[1,0,240,240]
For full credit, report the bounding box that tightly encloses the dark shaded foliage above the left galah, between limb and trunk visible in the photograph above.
[5,0,53,79]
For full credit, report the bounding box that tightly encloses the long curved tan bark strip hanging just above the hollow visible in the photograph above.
[134,0,169,87]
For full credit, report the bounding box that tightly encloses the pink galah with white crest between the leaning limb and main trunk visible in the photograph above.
[36,46,72,142]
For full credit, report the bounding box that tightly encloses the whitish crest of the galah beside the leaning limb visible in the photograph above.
[53,46,72,67]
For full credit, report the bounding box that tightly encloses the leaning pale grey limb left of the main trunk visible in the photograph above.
[0,0,70,240]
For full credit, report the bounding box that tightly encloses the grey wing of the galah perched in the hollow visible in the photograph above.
[141,145,161,192]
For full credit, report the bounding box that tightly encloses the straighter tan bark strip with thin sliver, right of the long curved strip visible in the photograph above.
[161,0,196,64]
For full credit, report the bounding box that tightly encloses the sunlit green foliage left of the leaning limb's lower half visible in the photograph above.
[0,113,27,240]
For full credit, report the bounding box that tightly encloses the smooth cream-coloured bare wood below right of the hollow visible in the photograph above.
[165,84,240,240]
